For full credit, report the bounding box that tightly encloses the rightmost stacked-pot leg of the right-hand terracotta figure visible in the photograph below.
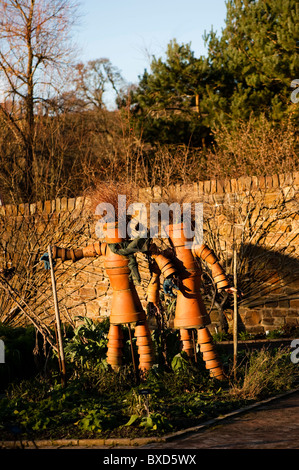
[197,327,225,380]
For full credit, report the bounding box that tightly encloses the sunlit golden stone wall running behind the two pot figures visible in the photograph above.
[0,172,299,333]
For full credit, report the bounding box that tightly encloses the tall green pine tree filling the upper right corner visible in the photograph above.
[203,0,299,125]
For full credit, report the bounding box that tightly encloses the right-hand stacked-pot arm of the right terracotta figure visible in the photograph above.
[192,245,234,292]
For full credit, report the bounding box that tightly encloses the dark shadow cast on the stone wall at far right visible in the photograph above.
[213,244,299,331]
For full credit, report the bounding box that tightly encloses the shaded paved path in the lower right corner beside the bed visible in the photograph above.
[143,392,299,449]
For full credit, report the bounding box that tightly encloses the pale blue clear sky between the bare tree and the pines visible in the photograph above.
[75,0,226,106]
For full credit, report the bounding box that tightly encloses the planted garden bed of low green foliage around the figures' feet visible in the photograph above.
[0,324,299,441]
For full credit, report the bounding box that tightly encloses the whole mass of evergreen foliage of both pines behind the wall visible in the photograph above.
[127,0,299,146]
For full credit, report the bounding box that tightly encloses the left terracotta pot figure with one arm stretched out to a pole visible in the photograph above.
[52,223,175,371]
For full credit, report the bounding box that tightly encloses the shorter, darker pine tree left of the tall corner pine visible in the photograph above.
[132,39,208,146]
